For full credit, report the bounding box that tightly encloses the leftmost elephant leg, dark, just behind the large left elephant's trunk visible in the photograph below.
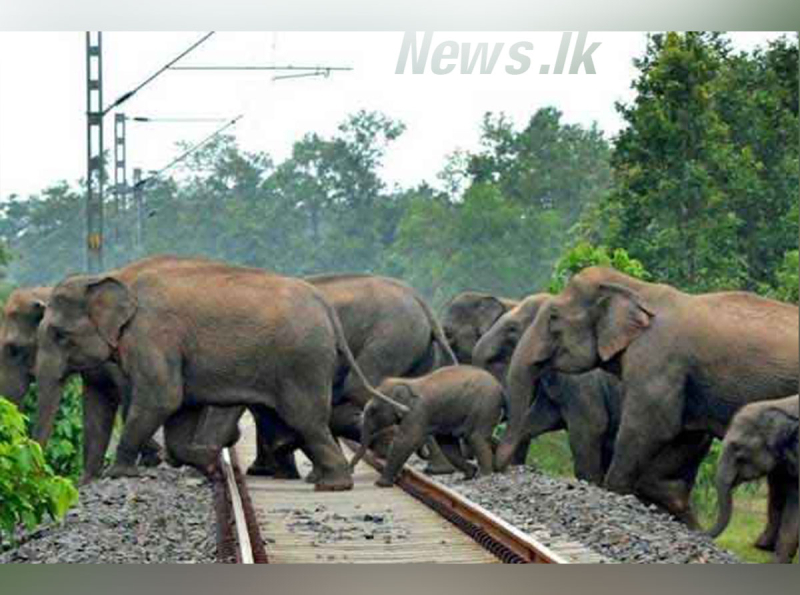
[81,379,119,484]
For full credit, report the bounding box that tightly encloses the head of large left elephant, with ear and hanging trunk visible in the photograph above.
[34,276,138,445]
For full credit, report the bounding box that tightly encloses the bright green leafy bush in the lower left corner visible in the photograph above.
[0,397,78,542]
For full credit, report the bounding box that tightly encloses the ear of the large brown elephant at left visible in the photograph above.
[86,277,138,348]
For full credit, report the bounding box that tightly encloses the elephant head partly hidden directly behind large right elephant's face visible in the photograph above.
[472,293,551,383]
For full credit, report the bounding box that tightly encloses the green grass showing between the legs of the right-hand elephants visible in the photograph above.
[527,432,797,564]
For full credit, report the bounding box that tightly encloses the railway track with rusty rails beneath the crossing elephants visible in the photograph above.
[215,416,606,564]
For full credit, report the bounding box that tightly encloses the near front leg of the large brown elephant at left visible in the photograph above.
[108,351,183,477]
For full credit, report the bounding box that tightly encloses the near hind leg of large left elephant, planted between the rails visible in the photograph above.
[277,378,353,491]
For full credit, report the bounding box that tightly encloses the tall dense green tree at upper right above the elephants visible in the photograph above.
[581,32,800,291]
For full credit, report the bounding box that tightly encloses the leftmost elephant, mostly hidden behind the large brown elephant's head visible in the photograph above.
[0,284,161,483]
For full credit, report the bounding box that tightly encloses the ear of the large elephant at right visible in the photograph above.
[596,283,655,362]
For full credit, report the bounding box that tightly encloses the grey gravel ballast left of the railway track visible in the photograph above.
[0,465,216,564]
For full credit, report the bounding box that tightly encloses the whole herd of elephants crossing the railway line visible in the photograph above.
[0,256,800,562]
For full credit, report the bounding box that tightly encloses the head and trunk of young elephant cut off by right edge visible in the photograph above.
[709,397,798,538]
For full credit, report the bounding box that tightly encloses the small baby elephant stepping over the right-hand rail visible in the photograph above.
[351,366,503,487]
